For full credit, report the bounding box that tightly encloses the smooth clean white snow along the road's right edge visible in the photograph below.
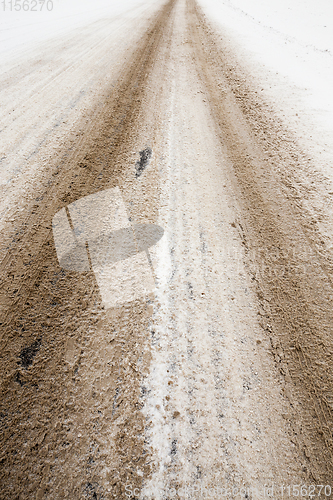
[200,0,333,180]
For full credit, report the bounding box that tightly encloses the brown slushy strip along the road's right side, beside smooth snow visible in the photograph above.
[189,1,333,482]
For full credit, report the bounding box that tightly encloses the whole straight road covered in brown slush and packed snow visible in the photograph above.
[0,0,333,499]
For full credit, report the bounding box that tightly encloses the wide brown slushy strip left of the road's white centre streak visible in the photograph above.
[0,2,173,499]
